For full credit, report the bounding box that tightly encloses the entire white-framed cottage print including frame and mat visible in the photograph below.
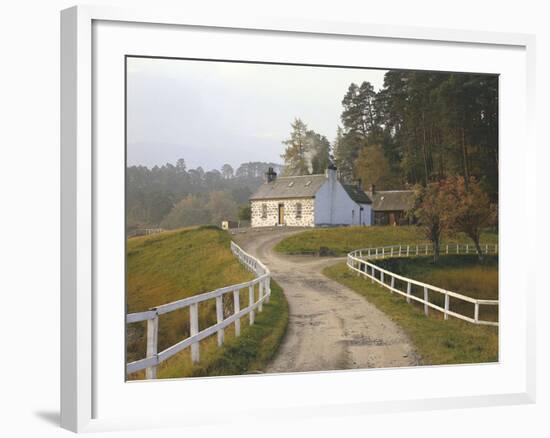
[61,7,535,431]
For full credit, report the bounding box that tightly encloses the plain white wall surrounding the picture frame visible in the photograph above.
[0,0,550,437]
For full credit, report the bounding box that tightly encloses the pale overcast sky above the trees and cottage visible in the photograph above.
[127,58,385,170]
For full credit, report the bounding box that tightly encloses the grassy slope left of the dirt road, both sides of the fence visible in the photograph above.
[126,227,288,379]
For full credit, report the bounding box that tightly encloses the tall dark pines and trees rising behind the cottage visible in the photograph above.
[282,71,498,202]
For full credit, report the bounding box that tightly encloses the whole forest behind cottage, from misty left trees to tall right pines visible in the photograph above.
[126,71,498,231]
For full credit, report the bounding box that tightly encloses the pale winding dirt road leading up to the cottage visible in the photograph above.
[234,230,417,373]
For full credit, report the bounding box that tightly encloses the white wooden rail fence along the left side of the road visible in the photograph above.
[126,242,271,379]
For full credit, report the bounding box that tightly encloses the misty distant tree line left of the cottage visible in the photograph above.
[126,158,282,231]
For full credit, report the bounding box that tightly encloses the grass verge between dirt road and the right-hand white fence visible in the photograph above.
[323,263,498,365]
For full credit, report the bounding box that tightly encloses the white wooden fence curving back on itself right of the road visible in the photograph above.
[347,244,498,326]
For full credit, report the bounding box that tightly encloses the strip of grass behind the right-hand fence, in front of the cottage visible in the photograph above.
[275,225,498,256]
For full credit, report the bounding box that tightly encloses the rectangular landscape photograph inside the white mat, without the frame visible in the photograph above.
[125,55,504,381]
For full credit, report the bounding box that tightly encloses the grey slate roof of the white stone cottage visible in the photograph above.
[250,174,327,201]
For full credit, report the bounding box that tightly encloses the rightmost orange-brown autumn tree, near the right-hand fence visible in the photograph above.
[441,176,497,260]
